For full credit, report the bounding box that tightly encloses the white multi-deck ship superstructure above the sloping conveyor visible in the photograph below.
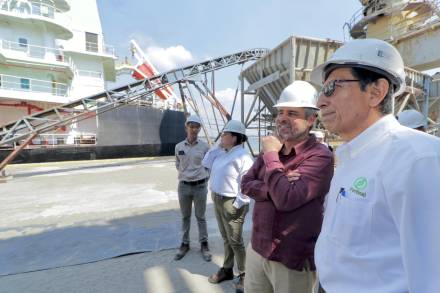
[0,0,117,125]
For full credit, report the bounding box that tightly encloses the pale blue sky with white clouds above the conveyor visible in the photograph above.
[97,0,361,120]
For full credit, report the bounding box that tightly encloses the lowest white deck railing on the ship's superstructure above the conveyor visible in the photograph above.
[0,74,69,97]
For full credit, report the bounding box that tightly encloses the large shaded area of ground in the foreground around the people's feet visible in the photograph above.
[0,204,250,293]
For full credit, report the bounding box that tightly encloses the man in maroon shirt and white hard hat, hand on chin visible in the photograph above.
[241,81,333,293]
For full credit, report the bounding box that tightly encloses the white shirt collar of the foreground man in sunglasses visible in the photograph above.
[336,114,400,159]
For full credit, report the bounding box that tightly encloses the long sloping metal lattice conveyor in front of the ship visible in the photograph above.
[0,48,268,176]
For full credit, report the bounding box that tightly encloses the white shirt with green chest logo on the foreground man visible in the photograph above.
[315,115,440,293]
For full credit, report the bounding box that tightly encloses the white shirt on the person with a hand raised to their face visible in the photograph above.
[202,145,254,208]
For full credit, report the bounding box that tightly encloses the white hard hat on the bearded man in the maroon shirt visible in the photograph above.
[274,80,319,110]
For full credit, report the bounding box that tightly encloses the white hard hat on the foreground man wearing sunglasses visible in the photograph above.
[311,39,406,96]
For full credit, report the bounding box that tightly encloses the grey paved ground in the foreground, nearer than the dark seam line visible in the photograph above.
[0,237,248,293]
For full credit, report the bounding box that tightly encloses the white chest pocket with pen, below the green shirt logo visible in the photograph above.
[329,196,373,255]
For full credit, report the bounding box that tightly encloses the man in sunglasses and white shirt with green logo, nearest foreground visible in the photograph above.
[312,39,440,293]
